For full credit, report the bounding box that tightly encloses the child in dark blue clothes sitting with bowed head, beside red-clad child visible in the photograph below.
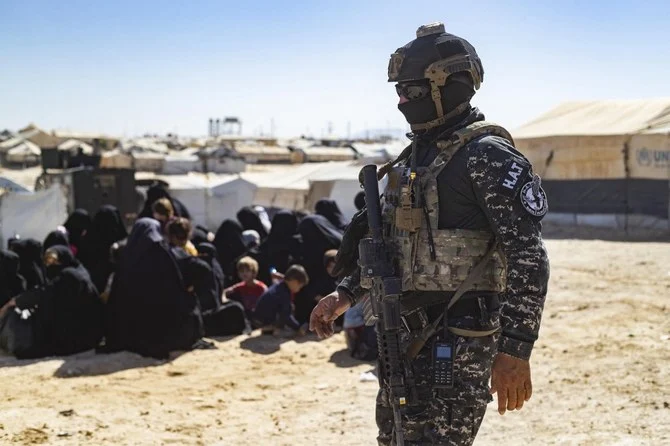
[253,265,309,335]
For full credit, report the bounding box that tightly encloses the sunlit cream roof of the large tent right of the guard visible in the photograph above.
[512,98,670,139]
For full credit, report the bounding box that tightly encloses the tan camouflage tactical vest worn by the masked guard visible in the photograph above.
[376,121,512,294]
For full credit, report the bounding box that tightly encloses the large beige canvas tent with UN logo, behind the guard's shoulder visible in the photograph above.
[512,99,670,231]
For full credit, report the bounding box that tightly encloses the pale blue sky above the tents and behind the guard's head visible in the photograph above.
[0,0,670,136]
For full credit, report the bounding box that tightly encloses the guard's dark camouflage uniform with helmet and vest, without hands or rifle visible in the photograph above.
[336,22,549,445]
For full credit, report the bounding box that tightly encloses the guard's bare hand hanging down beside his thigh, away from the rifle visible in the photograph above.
[491,353,533,415]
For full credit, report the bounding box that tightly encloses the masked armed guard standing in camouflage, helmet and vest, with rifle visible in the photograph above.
[311,23,549,445]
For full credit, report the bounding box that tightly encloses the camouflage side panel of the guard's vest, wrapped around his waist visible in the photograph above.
[411,228,506,292]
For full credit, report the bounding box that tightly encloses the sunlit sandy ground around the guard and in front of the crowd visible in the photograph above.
[0,240,670,445]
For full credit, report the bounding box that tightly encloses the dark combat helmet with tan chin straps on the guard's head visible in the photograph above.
[388,22,484,130]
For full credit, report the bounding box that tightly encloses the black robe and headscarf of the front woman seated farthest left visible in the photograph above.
[16,245,103,357]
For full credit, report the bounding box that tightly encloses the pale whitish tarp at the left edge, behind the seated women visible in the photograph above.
[0,185,68,246]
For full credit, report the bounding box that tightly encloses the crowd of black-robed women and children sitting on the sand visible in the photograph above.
[0,185,376,359]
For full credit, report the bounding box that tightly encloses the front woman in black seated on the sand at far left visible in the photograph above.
[0,245,103,358]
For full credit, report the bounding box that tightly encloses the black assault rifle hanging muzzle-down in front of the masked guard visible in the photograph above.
[358,164,407,446]
